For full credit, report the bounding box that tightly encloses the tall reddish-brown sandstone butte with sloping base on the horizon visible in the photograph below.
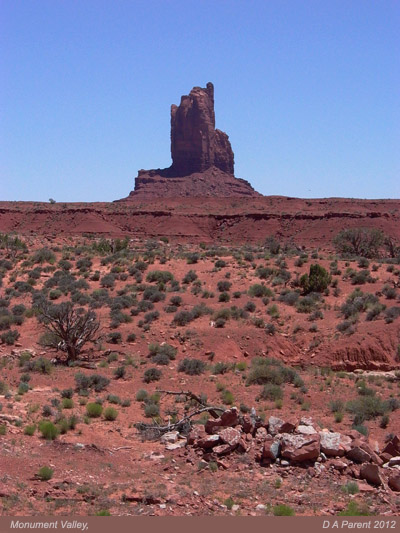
[123,82,260,200]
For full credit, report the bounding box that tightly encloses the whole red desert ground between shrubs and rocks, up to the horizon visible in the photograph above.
[0,203,400,516]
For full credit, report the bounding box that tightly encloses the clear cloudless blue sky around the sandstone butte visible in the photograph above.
[0,0,400,201]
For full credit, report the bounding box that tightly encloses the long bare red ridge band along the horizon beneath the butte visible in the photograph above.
[0,196,400,250]
